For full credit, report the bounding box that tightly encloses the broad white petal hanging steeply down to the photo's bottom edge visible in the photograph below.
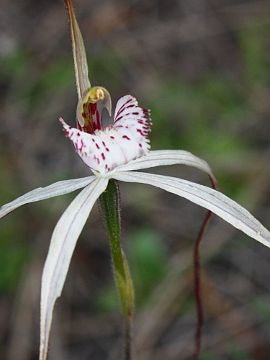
[39,178,108,360]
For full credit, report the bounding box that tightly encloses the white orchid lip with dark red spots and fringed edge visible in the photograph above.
[60,95,150,174]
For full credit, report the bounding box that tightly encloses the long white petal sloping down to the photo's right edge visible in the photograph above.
[113,172,270,247]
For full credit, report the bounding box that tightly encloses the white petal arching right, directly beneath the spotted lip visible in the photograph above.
[117,150,214,179]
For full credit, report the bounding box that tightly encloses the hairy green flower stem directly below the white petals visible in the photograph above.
[100,180,134,360]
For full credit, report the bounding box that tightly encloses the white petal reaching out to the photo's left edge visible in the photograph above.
[0,176,95,218]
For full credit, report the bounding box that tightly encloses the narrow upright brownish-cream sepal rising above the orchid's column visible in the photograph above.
[65,0,91,100]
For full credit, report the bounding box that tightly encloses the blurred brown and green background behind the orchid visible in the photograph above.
[0,0,270,360]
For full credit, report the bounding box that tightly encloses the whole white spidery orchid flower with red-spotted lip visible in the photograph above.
[0,0,270,360]
